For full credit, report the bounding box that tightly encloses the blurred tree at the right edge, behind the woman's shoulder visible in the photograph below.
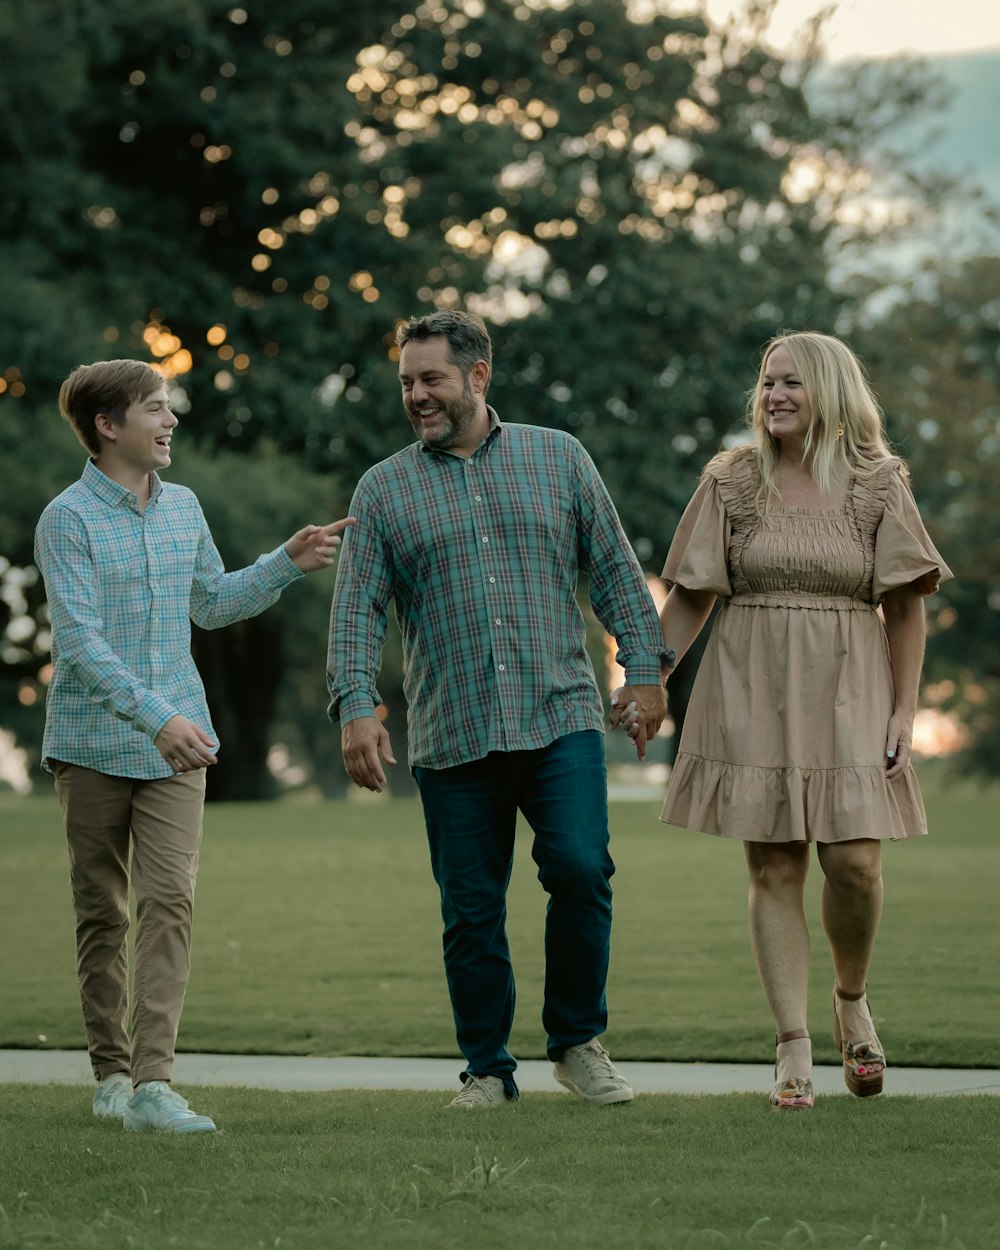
[853,256,1000,776]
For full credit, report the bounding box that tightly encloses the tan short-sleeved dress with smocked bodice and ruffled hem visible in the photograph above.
[660,448,951,843]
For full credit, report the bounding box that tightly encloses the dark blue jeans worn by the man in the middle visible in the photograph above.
[414,730,615,1098]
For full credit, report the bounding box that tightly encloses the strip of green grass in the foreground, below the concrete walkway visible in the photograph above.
[0,1086,1000,1250]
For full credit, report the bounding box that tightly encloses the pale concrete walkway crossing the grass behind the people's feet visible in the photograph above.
[0,1050,1000,1094]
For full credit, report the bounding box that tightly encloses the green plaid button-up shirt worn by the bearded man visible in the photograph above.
[329,409,663,769]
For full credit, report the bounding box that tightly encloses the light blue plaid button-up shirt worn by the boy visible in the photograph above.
[35,461,304,780]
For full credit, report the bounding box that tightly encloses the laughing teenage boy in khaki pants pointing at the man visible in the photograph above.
[35,360,350,1133]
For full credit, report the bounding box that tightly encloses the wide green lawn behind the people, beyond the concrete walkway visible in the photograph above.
[0,784,1000,1065]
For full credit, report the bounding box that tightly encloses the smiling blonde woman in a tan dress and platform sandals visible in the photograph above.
[613,333,951,1109]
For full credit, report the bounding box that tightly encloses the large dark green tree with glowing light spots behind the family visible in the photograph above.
[0,0,970,790]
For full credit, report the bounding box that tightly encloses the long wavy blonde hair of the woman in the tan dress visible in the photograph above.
[746,330,893,506]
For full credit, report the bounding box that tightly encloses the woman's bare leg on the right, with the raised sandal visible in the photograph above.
[819,838,883,1043]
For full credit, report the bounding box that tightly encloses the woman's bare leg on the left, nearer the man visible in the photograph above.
[744,843,813,1080]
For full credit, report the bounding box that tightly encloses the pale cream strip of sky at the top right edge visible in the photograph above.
[691,0,1000,60]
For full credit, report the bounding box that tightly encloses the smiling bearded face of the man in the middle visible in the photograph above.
[399,334,490,455]
